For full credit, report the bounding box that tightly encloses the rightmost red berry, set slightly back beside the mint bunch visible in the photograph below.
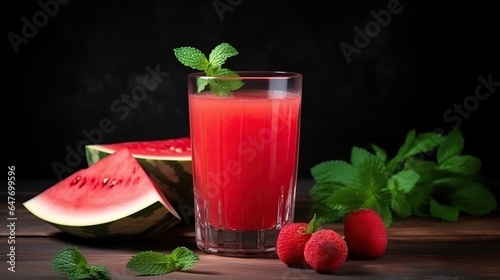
[344,209,388,259]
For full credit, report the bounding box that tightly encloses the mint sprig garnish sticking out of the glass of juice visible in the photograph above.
[174,43,243,96]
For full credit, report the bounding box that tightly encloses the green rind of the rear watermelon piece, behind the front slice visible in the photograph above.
[85,145,194,223]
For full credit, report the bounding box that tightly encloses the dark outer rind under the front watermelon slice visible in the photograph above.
[51,201,180,240]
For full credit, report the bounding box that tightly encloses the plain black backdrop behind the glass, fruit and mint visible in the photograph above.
[2,0,500,197]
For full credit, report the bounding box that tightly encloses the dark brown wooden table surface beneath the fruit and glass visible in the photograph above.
[0,181,500,280]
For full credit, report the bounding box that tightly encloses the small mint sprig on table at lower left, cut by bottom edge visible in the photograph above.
[51,247,111,280]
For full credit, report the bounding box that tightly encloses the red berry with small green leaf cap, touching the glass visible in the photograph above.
[276,217,319,266]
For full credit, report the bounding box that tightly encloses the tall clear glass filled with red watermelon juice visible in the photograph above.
[188,71,302,256]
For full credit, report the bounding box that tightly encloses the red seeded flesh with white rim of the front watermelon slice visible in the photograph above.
[24,149,180,226]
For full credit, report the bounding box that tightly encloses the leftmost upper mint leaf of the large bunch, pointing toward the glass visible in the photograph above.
[311,160,359,186]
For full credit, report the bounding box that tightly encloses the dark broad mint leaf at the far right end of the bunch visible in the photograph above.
[451,183,497,215]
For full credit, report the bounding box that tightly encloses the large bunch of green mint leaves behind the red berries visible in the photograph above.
[310,129,497,227]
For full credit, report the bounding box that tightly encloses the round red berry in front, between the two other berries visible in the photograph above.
[304,229,348,273]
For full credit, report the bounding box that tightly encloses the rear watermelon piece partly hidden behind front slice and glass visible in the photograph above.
[85,137,194,224]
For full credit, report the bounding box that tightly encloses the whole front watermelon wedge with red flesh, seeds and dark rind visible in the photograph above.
[23,149,180,239]
